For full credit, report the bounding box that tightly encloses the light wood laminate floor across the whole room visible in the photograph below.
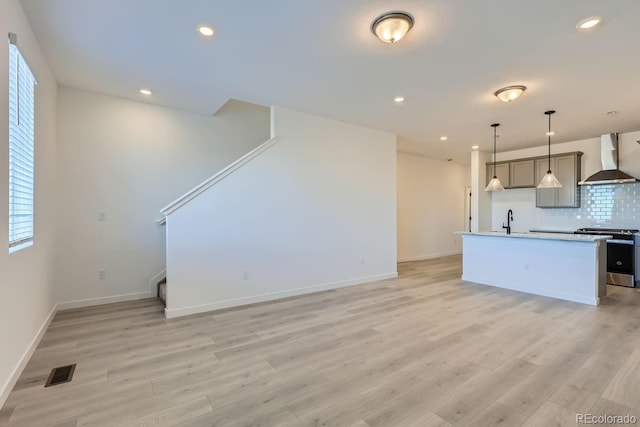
[0,257,640,427]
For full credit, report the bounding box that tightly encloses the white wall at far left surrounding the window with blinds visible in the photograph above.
[0,0,57,407]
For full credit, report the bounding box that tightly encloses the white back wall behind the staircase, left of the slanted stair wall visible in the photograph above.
[56,88,269,308]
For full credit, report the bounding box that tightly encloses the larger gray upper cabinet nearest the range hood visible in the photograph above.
[536,153,582,208]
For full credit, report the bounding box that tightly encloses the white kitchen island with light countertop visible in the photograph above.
[456,232,610,305]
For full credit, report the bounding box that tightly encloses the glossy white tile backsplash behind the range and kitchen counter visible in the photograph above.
[492,183,640,231]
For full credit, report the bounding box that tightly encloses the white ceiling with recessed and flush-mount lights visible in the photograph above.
[17,0,640,162]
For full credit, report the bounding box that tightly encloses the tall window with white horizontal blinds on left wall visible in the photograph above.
[9,34,36,252]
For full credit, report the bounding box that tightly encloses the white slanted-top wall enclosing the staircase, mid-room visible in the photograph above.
[167,107,397,317]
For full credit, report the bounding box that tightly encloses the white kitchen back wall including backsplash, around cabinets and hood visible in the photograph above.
[491,132,640,231]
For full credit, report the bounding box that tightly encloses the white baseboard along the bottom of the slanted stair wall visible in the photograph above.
[164,271,398,319]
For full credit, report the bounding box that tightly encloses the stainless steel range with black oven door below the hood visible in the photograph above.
[575,228,640,288]
